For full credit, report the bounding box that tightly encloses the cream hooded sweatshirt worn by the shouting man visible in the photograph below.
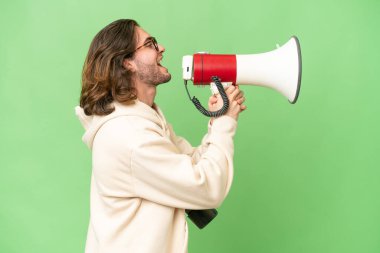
[76,100,237,253]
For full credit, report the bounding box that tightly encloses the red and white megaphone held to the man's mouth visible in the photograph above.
[182,36,302,116]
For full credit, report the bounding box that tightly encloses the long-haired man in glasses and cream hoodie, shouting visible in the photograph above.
[76,19,246,253]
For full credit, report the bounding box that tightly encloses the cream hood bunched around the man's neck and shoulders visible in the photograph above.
[75,100,166,149]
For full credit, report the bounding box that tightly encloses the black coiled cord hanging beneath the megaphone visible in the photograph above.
[185,76,229,117]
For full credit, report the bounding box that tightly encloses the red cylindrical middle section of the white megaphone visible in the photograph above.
[193,54,236,85]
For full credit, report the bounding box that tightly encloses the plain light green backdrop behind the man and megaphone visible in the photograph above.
[0,0,380,253]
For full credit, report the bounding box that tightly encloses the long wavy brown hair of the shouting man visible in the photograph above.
[80,19,139,115]
